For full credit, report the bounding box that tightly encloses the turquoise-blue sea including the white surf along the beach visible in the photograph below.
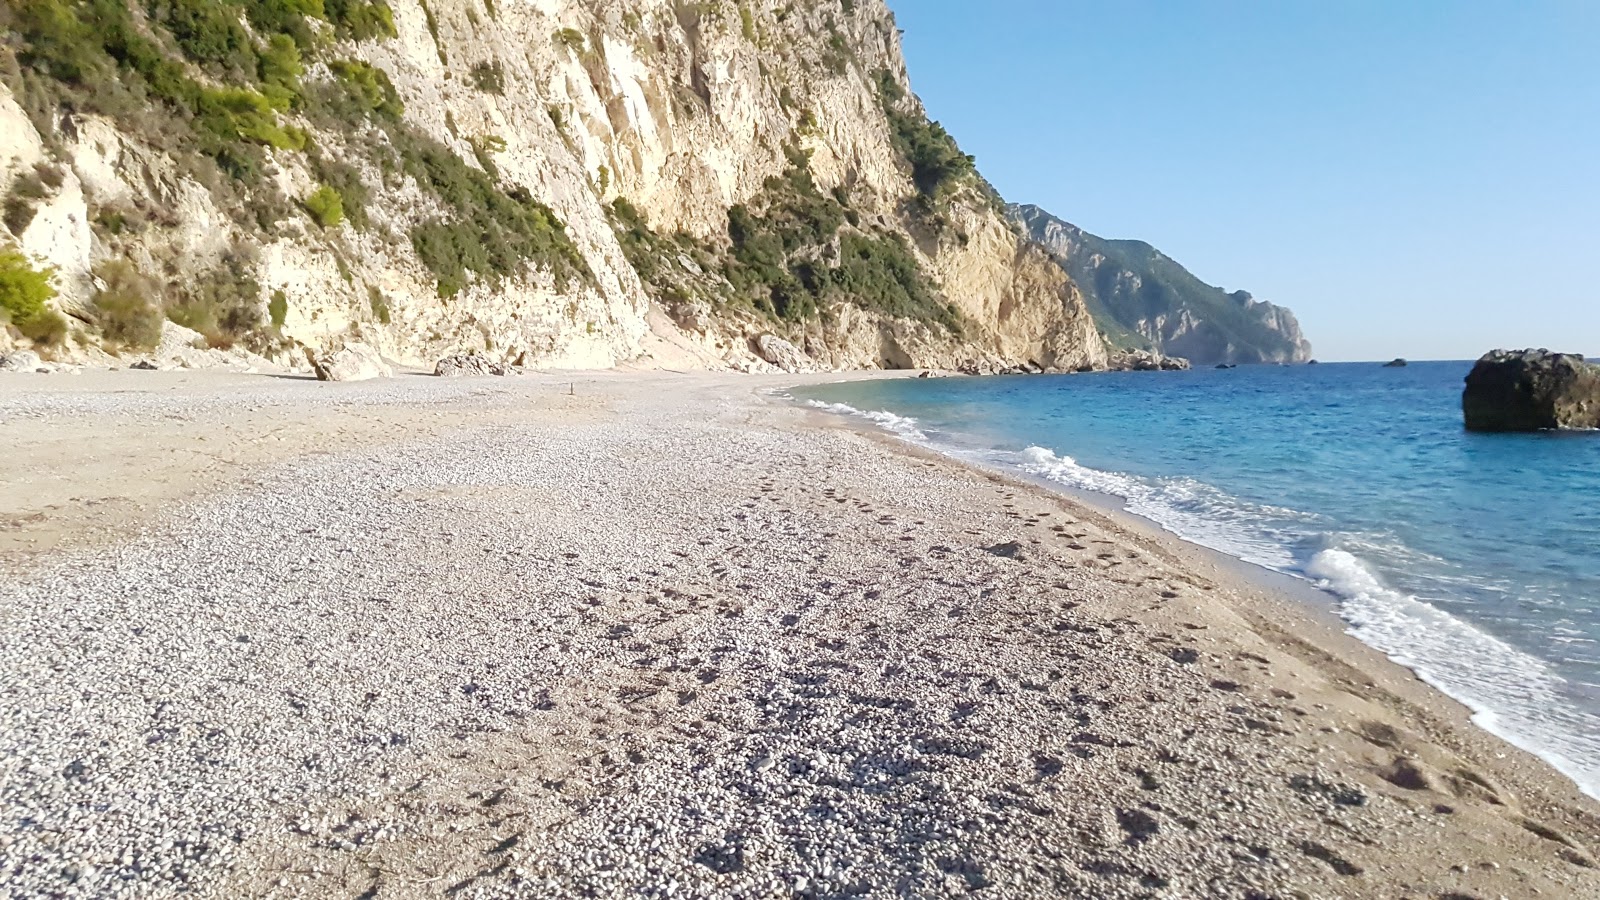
[795,362,1600,798]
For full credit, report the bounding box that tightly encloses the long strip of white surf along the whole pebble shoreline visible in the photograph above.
[808,400,1600,799]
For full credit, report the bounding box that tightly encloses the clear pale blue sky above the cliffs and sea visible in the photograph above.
[890,0,1600,360]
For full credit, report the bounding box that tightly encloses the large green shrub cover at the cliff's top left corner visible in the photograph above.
[0,0,395,184]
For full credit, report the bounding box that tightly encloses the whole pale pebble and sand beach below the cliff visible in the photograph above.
[0,372,1600,898]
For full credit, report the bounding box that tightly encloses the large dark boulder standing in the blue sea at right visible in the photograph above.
[1461,349,1600,431]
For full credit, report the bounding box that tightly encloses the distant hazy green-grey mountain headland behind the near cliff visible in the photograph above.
[1010,205,1310,365]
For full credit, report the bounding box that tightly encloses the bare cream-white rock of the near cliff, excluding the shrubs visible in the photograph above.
[0,0,1104,368]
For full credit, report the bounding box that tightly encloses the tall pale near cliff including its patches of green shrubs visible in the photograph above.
[0,0,1106,368]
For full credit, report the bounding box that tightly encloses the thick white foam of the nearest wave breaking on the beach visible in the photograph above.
[1306,549,1600,799]
